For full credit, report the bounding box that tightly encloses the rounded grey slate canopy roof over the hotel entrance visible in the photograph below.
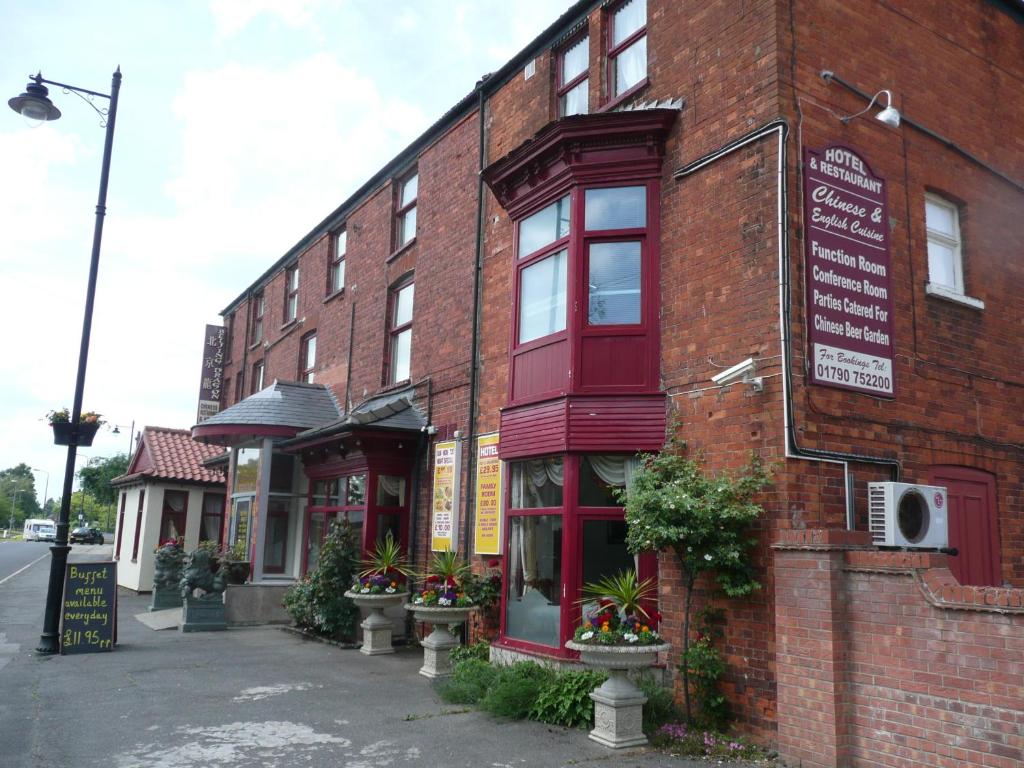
[196,380,341,429]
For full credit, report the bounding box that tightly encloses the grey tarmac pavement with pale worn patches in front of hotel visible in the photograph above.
[0,547,765,768]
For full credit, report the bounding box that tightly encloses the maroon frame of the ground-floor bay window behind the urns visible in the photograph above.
[498,452,658,658]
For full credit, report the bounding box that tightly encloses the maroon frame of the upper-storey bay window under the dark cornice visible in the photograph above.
[508,182,660,406]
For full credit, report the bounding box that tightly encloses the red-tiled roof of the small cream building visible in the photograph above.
[111,427,224,485]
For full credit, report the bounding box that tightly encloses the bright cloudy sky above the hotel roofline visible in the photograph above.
[0,0,570,503]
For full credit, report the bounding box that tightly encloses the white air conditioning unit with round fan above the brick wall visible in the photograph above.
[867,482,949,549]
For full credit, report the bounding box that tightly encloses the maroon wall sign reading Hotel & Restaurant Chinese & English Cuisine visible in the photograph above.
[804,144,895,397]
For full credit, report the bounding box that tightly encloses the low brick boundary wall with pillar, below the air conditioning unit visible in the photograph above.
[775,530,1024,768]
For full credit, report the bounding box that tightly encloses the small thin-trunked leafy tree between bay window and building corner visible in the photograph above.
[618,440,768,723]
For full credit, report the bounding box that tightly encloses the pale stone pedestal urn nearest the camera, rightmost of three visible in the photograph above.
[565,640,672,750]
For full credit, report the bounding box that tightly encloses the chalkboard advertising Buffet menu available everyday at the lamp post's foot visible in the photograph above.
[60,561,118,653]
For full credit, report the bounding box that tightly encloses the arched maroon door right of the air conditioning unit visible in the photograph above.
[928,466,1002,587]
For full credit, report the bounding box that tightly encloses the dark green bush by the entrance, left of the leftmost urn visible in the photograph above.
[283,520,359,640]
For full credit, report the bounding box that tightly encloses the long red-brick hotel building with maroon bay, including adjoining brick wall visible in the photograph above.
[194,0,1024,766]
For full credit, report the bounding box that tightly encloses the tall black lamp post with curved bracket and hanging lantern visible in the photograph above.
[7,67,121,653]
